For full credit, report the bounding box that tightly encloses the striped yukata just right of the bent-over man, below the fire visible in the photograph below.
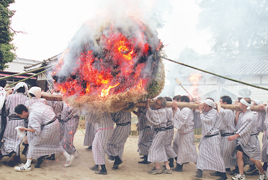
[61,103,79,155]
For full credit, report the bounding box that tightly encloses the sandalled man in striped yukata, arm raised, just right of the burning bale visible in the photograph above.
[146,97,172,175]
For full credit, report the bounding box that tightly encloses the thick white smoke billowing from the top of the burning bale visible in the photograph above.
[57,0,170,76]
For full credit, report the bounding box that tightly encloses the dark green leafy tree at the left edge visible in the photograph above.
[0,0,16,70]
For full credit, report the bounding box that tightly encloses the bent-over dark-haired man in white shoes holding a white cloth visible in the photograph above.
[15,102,74,171]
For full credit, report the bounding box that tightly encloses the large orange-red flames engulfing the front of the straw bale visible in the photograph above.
[53,18,159,97]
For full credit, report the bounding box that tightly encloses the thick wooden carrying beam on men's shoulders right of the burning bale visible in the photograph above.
[135,102,263,111]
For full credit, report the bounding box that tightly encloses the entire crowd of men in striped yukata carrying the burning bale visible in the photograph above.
[0,81,268,180]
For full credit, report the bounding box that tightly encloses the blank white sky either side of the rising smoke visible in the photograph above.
[10,0,210,61]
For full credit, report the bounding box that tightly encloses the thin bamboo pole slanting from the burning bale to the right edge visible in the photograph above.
[161,57,268,91]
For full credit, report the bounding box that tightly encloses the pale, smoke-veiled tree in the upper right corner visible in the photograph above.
[198,0,268,56]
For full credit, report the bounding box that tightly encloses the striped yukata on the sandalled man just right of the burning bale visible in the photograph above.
[146,108,168,163]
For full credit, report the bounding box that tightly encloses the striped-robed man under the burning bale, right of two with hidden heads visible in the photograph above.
[107,111,131,170]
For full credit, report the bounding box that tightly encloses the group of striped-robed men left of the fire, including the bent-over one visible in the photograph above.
[0,80,79,171]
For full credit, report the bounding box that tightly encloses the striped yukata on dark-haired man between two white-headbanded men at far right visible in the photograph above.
[219,108,237,168]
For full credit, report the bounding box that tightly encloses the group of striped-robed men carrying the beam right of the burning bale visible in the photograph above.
[132,96,268,180]
